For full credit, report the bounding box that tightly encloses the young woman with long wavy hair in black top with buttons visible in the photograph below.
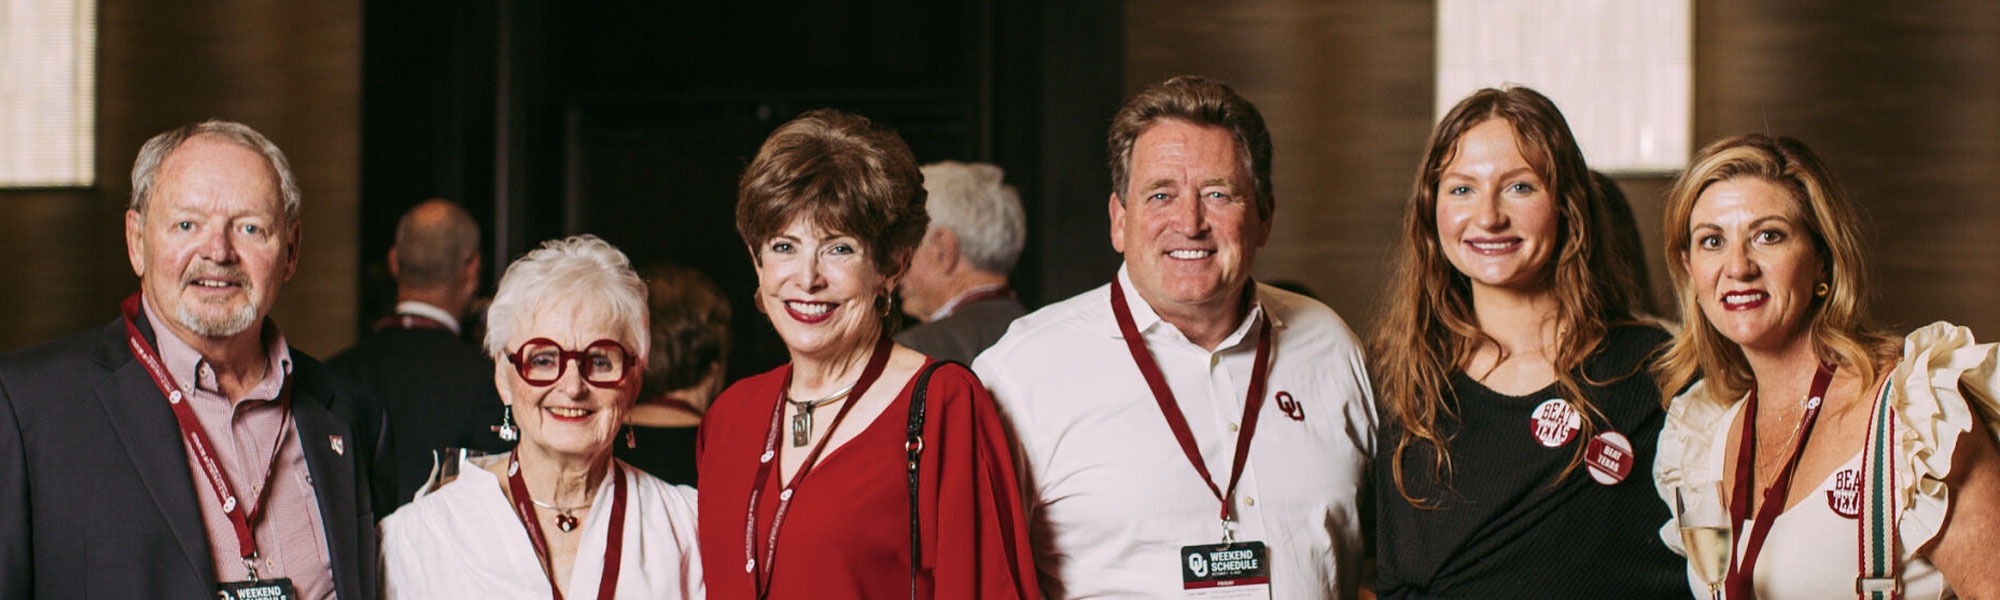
[1374,88,1686,598]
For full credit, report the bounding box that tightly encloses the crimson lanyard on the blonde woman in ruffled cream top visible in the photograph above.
[1724,364,1834,600]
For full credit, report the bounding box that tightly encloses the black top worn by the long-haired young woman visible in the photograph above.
[1374,326,1690,598]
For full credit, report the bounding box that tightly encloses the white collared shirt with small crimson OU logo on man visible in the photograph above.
[972,268,1376,598]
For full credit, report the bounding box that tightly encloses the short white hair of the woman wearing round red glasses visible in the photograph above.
[486,234,652,368]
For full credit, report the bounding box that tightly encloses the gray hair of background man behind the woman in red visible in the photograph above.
[924,160,1028,276]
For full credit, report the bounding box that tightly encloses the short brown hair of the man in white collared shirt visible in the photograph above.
[1106,76,1278,218]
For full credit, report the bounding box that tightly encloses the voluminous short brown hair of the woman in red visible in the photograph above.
[736,108,930,276]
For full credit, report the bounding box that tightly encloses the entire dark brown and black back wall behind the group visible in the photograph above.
[0,0,2000,354]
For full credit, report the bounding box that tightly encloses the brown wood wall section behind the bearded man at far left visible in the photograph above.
[0,0,362,356]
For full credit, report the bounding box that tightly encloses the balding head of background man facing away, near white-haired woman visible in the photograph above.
[396,198,480,290]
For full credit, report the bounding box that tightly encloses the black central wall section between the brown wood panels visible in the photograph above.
[360,0,1122,376]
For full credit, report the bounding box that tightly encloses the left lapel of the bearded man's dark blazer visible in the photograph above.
[96,318,216,588]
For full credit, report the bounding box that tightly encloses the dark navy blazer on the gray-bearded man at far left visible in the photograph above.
[0,318,392,600]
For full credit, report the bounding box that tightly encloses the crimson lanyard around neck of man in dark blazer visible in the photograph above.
[122,294,292,582]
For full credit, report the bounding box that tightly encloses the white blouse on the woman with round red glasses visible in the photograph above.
[382,456,706,600]
